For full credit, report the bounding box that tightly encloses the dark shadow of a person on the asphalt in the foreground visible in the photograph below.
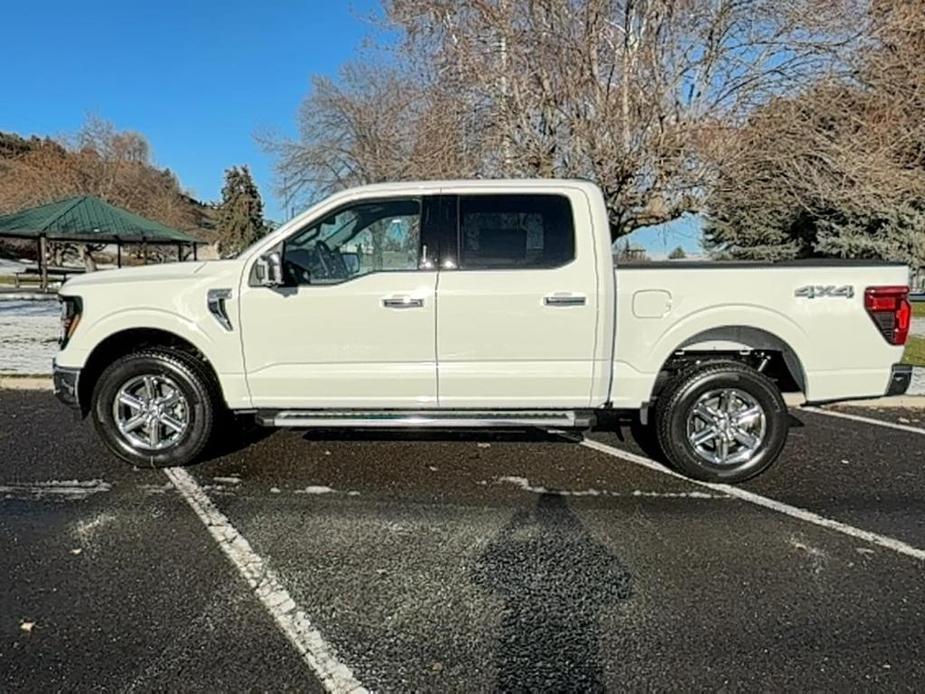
[470,493,632,692]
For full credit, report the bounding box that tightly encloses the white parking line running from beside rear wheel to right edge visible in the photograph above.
[580,439,925,561]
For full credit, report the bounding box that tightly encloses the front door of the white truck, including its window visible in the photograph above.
[241,198,437,408]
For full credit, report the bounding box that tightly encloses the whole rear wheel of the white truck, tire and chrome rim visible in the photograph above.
[655,361,789,482]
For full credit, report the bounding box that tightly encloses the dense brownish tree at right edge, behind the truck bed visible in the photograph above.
[708,0,925,266]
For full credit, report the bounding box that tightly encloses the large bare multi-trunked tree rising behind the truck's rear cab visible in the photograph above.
[389,0,865,236]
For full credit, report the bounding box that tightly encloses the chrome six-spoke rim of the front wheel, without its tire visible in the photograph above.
[112,374,190,451]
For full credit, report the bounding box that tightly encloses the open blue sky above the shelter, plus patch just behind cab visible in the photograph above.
[0,0,699,255]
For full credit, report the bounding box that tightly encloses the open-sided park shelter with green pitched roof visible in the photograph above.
[0,195,204,288]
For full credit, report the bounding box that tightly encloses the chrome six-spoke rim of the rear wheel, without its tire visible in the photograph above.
[687,388,767,465]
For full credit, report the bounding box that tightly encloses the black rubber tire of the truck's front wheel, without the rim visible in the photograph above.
[91,347,221,468]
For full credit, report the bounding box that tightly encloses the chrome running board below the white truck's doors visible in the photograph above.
[257,410,594,429]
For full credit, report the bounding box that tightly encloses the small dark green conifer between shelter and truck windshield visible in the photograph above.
[216,166,269,256]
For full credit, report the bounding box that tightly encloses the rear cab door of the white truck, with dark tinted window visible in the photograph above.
[437,192,598,408]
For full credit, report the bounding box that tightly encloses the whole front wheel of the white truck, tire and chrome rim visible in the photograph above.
[92,348,216,467]
